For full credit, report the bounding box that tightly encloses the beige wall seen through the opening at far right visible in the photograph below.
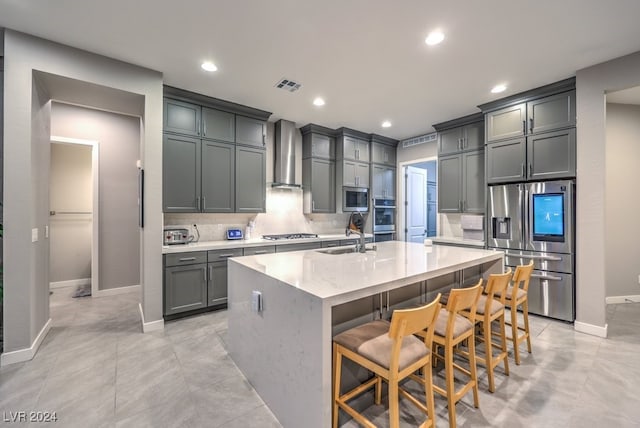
[605,103,640,297]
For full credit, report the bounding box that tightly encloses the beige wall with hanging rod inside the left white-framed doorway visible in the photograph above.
[49,144,92,283]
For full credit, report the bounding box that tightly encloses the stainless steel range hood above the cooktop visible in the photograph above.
[271,119,302,188]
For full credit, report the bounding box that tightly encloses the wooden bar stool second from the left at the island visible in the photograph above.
[433,279,482,427]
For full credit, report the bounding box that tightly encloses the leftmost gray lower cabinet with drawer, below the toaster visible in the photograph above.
[164,251,207,315]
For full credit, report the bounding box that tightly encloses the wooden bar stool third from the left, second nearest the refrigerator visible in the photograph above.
[475,269,511,392]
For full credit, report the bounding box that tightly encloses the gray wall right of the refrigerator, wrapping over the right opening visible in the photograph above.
[576,52,640,327]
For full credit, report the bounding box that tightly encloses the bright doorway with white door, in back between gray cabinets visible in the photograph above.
[398,157,438,243]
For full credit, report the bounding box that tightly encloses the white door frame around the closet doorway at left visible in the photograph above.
[49,135,100,297]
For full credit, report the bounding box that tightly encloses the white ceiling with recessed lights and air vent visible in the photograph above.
[0,0,640,139]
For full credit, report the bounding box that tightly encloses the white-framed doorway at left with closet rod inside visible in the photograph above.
[45,136,100,297]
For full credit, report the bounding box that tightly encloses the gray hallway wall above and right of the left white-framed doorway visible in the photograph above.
[51,103,140,290]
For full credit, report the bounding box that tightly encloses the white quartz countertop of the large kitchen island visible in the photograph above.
[229,241,503,304]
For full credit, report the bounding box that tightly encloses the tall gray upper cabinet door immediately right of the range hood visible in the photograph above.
[302,158,336,214]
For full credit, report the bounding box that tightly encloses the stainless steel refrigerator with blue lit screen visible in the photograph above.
[487,180,575,322]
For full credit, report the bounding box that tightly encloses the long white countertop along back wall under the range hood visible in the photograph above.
[162,233,373,254]
